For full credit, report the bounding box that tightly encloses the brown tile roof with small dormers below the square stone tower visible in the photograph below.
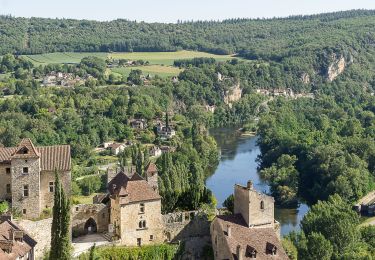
[215,214,289,260]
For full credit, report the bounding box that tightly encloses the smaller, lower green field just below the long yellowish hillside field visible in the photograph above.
[111,65,182,77]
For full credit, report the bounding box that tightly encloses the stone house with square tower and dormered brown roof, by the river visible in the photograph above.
[210,182,288,260]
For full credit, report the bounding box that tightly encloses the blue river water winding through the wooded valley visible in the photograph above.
[206,128,308,235]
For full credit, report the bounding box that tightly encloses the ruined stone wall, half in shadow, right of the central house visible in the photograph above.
[163,211,210,242]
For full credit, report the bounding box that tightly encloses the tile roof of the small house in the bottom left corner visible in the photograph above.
[0,221,37,260]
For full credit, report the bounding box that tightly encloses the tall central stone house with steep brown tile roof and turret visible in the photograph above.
[108,172,164,246]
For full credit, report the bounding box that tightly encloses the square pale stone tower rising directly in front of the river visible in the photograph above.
[234,181,275,227]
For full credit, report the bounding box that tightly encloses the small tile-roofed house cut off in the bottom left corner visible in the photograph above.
[0,220,37,260]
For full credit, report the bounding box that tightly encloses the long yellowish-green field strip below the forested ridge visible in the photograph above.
[109,51,238,65]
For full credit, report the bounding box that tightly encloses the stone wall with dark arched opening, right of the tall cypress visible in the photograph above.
[71,204,109,236]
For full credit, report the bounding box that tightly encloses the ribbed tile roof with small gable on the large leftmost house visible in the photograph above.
[0,139,71,171]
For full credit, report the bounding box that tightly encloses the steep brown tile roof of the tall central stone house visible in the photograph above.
[108,172,161,205]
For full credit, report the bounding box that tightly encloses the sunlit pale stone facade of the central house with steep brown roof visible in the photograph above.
[121,200,164,246]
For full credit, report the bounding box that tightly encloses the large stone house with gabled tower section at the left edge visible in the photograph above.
[0,139,71,219]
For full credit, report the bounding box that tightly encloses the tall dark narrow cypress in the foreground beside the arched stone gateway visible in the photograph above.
[49,171,71,260]
